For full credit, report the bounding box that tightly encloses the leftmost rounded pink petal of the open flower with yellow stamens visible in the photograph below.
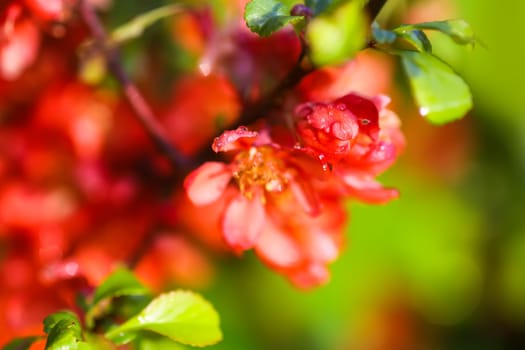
[184,162,232,205]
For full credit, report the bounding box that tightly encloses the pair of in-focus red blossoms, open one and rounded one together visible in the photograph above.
[185,94,403,288]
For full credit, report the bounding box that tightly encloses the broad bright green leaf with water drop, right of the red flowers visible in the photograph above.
[400,51,472,124]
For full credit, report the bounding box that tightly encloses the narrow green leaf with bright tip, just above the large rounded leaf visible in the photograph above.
[394,19,477,45]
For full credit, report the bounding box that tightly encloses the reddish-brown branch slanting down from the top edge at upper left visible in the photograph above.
[79,0,191,170]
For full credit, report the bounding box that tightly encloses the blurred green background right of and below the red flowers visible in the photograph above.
[193,0,525,350]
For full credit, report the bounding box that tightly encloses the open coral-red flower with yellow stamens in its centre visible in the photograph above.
[184,127,344,288]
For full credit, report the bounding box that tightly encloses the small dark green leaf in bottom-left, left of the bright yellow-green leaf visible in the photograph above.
[44,311,91,350]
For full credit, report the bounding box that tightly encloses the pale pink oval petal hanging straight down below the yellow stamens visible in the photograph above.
[222,194,266,253]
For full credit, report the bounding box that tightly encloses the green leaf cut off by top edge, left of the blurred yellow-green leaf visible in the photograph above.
[244,0,304,36]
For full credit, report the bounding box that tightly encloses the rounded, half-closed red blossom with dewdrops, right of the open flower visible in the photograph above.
[295,94,404,203]
